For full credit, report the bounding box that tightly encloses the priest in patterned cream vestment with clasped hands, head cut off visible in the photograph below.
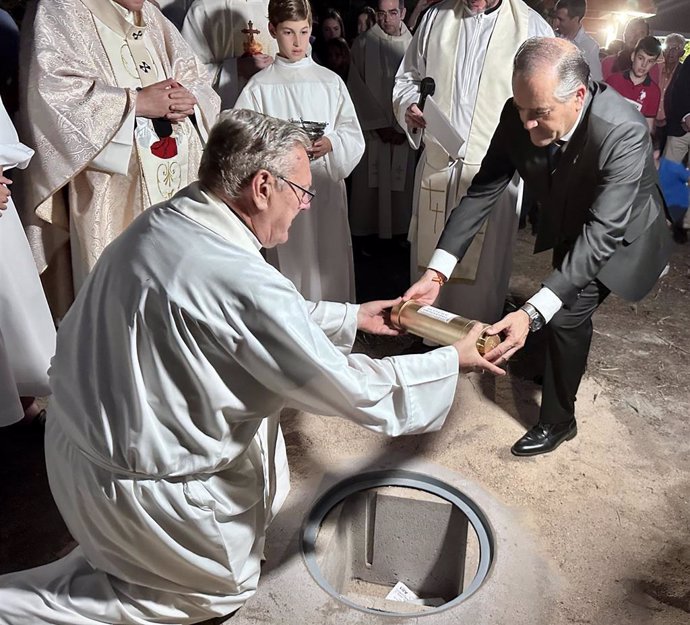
[20,0,219,316]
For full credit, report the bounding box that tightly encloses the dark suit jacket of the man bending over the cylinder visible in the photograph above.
[438,82,671,306]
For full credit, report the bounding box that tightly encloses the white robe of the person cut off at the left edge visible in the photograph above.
[0,100,55,426]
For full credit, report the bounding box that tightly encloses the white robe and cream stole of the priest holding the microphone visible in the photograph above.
[393,0,553,323]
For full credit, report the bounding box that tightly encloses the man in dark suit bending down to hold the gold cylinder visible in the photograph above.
[405,38,671,456]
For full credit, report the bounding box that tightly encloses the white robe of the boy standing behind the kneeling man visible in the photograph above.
[235,56,364,302]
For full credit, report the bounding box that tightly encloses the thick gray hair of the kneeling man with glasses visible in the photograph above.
[199,109,311,200]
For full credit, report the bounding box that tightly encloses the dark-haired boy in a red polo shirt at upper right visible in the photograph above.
[606,37,661,132]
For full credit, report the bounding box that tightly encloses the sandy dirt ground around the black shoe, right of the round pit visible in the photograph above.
[350,230,690,625]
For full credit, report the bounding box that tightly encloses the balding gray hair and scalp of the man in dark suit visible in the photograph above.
[513,37,589,102]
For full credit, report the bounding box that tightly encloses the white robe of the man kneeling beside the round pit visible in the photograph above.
[0,184,458,625]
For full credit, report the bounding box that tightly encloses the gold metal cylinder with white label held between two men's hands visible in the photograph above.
[391,300,501,356]
